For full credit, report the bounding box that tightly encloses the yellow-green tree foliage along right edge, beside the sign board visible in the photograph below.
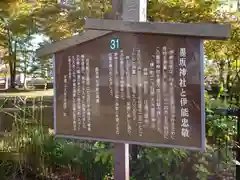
[205,14,240,104]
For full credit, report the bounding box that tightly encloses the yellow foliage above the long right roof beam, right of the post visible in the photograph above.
[148,0,218,23]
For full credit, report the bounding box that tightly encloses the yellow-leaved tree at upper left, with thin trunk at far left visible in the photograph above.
[0,0,110,88]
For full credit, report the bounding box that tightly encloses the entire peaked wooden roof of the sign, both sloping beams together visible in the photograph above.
[36,18,230,57]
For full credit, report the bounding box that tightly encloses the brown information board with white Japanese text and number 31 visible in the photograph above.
[54,32,205,150]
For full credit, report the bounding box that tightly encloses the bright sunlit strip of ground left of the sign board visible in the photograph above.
[0,89,53,97]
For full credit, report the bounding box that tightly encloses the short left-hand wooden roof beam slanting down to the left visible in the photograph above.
[36,30,111,57]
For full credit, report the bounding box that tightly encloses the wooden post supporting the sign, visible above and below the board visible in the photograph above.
[112,0,147,180]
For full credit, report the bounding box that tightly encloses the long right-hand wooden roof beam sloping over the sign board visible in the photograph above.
[85,18,230,40]
